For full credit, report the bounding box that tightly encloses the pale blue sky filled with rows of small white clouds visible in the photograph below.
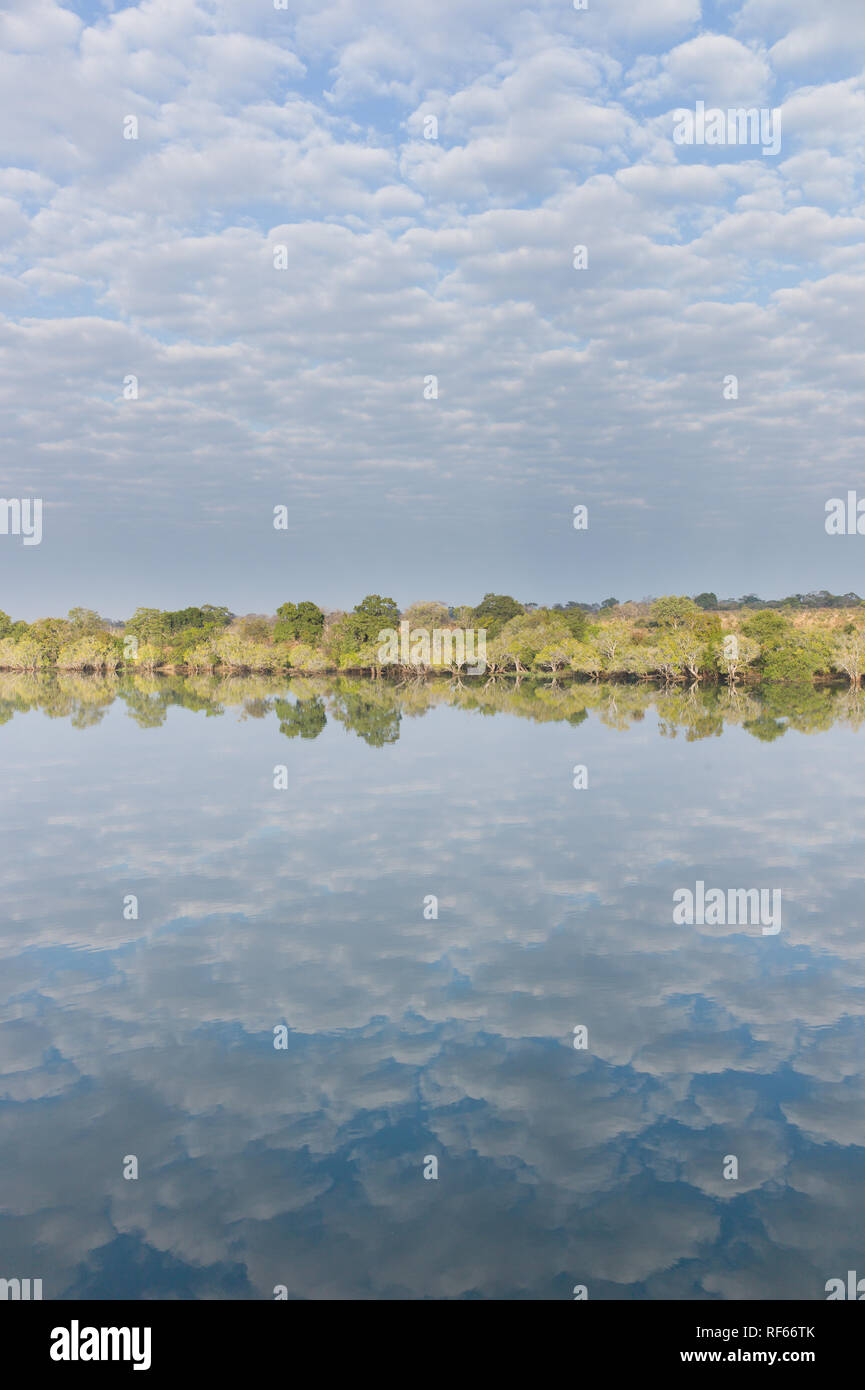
[0,0,865,619]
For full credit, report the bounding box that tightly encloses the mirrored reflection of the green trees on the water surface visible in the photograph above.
[0,671,865,748]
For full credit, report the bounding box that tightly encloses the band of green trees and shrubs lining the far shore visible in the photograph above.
[0,592,865,688]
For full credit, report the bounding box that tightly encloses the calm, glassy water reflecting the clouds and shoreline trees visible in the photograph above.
[0,676,865,1300]
